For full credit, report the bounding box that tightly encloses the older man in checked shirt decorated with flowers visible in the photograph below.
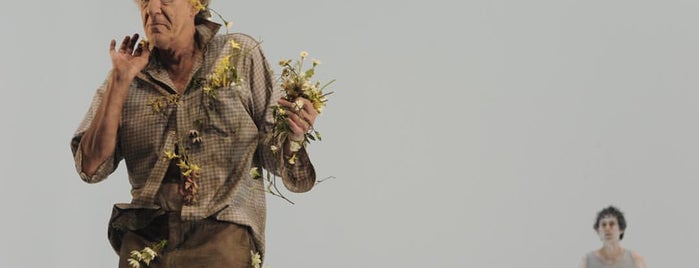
[71,0,317,267]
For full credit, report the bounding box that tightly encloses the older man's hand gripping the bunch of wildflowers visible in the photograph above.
[277,98,318,141]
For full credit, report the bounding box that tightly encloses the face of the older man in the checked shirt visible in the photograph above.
[138,0,197,49]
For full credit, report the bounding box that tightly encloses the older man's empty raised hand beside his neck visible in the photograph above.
[109,34,150,81]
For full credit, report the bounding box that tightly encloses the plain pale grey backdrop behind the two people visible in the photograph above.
[0,0,699,268]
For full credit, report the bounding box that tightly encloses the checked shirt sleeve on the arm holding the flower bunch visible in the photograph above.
[241,37,316,193]
